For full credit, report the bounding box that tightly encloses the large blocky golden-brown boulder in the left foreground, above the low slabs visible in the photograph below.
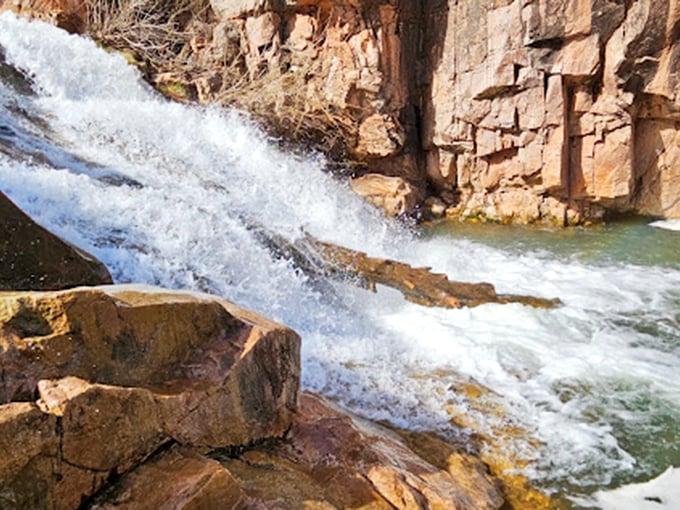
[0,287,300,508]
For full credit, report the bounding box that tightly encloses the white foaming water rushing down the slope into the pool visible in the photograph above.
[0,14,680,508]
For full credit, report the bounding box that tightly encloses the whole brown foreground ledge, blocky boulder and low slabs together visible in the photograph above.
[0,286,516,509]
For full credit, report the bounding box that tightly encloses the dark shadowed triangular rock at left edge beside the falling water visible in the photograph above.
[0,192,111,290]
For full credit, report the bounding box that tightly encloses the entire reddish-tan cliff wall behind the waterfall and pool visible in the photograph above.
[0,0,680,224]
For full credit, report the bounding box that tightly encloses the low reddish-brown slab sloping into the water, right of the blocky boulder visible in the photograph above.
[216,394,503,509]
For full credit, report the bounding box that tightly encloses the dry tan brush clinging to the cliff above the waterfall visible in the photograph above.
[86,0,357,156]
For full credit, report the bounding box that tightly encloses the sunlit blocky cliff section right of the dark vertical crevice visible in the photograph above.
[422,0,680,222]
